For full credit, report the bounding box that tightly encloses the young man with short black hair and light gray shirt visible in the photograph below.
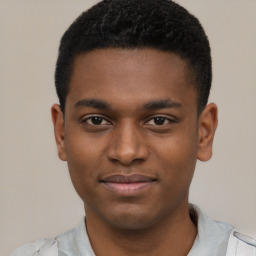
[13,0,256,256]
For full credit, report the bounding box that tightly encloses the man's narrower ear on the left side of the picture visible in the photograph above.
[51,104,67,161]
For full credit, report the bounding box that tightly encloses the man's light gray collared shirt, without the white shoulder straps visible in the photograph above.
[11,205,233,256]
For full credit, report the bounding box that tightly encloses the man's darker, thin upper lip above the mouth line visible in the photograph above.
[101,174,156,183]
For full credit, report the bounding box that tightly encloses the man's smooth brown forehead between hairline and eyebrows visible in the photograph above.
[67,48,195,111]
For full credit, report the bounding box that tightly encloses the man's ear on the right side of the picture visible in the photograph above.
[197,103,218,161]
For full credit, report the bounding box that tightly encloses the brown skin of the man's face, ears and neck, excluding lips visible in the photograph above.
[52,49,217,256]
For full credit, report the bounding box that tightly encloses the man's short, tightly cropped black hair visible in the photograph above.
[55,0,212,113]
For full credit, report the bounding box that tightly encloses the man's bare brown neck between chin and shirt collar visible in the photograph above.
[86,204,197,256]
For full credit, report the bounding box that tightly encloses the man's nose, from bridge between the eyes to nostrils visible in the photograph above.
[107,123,149,165]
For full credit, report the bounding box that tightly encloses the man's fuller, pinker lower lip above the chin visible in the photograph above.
[103,181,154,197]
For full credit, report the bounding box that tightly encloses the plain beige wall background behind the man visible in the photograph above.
[0,0,256,255]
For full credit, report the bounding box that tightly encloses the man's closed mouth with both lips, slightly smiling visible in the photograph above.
[101,174,156,197]
